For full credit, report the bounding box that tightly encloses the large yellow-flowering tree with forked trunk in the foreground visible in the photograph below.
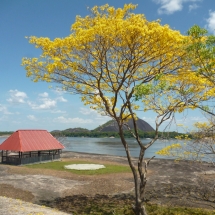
[22,4,193,215]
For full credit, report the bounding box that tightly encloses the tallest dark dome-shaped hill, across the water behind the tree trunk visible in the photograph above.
[93,118,154,132]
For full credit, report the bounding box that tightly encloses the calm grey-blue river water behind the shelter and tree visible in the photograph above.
[0,137,174,158]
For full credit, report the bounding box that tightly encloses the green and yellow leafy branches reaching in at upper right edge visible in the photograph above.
[187,25,215,116]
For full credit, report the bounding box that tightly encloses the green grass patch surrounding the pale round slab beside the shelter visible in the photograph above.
[26,160,131,175]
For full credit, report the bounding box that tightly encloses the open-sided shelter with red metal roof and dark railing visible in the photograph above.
[0,130,64,165]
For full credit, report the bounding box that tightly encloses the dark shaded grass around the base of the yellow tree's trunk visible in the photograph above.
[47,195,215,215]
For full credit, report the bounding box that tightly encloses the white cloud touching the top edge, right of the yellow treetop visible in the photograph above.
[153,0,201,14]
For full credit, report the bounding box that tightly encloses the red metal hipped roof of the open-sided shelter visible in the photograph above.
[0,130,64,152]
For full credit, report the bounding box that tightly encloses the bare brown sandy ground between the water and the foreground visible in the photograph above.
[0,152,215,215]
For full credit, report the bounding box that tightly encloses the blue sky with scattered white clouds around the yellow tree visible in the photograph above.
[0,0,215,131]
